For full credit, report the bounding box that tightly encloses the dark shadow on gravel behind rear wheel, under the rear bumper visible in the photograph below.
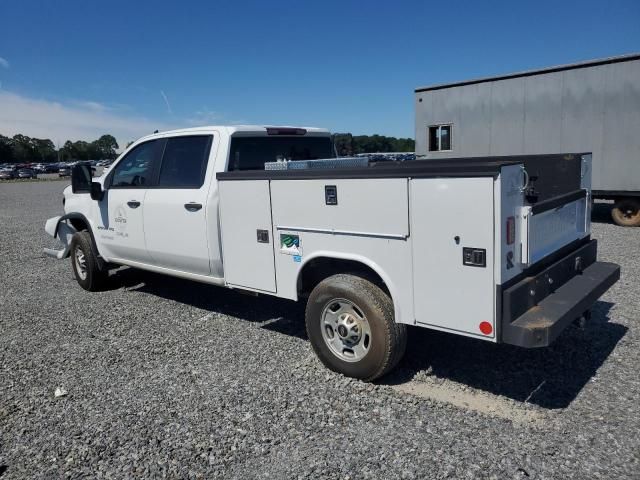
[383,301,628,409]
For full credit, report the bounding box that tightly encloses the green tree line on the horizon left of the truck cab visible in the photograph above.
[0,134,120,163]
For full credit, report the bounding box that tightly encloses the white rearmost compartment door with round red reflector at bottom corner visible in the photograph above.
[410,177,496,341]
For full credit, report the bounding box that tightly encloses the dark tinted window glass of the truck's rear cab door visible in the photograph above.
[158,135,213,188]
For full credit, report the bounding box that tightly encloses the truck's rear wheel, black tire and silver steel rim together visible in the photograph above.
[305,274,407,381]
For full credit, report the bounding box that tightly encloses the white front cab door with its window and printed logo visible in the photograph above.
[96,140,161,263]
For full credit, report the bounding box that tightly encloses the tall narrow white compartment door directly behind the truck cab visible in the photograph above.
[218,180,276,292]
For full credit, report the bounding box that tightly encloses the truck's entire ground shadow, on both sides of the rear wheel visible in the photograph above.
[110,268,627,409]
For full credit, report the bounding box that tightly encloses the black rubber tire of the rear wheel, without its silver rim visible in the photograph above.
[305,274,407,381]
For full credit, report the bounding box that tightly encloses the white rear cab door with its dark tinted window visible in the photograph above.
[144,135,215,275]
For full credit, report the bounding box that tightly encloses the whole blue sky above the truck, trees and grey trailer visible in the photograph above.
[0,0,640,147]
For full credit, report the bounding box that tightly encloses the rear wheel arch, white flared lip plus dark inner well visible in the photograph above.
[296,252,401,323]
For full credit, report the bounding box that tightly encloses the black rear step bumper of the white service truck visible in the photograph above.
[500,240,620,348]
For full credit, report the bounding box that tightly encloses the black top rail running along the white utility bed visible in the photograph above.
[217,153,583,180]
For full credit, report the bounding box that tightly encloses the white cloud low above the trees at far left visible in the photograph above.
[0,91,177,148]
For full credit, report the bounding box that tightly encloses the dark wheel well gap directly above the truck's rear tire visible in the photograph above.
[298,257,391,298]
